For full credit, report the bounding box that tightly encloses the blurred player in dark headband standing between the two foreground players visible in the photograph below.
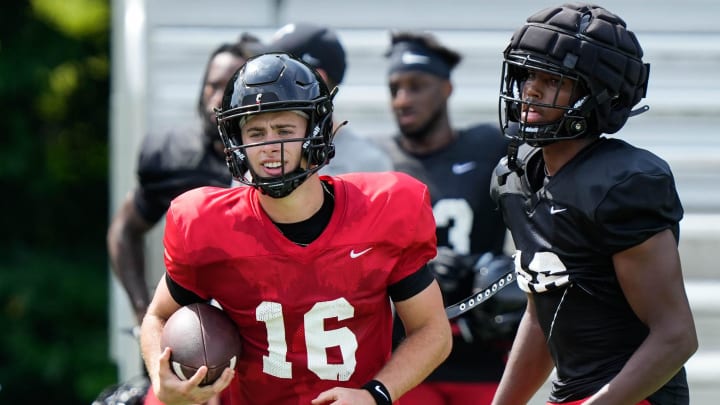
[384,31,525,405]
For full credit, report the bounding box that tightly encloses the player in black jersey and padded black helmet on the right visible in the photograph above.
[492,3,698,405]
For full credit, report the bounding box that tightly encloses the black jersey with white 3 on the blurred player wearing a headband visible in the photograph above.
[383,124,510,381]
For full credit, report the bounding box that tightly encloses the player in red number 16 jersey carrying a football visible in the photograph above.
[141,53,452,405]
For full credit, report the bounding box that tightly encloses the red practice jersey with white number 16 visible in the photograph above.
[164,173,436,405]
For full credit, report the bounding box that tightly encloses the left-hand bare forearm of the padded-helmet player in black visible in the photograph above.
[492,294,553,405]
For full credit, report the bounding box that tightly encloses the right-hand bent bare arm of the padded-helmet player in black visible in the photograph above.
[585,230,698,405]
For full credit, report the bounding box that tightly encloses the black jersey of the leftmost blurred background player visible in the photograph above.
[134,130,232,224]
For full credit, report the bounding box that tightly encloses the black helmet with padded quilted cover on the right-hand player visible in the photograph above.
[499,4,650,146]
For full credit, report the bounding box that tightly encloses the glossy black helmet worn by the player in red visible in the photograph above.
[217,52,335,198]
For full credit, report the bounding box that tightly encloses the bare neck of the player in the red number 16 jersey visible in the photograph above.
[258,173,324,224]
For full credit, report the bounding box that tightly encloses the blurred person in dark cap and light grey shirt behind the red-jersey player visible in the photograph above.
[267,23,393,175]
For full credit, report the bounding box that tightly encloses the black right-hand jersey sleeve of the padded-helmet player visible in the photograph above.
[595,173,683,254]
